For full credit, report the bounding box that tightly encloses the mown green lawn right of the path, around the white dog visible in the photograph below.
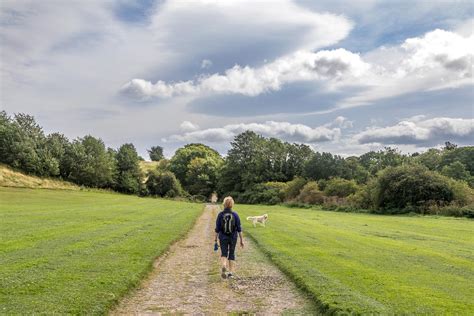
[236,205,474,315]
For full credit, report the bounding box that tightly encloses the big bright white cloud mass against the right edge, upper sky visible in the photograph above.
[339,30,474,108]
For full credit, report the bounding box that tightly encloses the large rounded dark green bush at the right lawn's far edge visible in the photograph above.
[374,165,455,213]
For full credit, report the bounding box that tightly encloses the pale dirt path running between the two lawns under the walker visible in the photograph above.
[111,205,315,315]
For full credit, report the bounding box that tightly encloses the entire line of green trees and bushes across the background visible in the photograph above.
[0,111,474,216]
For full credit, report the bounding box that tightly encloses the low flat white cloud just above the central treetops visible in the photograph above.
[163,117,347,143]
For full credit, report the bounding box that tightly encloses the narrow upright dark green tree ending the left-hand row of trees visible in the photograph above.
[115,144,142,194]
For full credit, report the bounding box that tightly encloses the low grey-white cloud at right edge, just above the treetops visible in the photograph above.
[354,115,474,144]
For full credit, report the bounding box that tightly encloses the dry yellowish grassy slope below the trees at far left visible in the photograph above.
[0,164,80,190]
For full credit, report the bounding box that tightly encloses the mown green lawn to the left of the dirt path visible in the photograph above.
[0,188,202,314]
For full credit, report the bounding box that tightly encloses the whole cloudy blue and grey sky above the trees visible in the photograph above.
[0,0,474,159]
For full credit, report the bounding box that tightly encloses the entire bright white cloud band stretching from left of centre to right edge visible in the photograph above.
[121,25,474,108]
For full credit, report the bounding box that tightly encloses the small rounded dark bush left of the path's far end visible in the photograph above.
[146,171,184,198]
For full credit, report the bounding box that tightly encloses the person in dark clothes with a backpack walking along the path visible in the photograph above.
[214,196,244,279]
